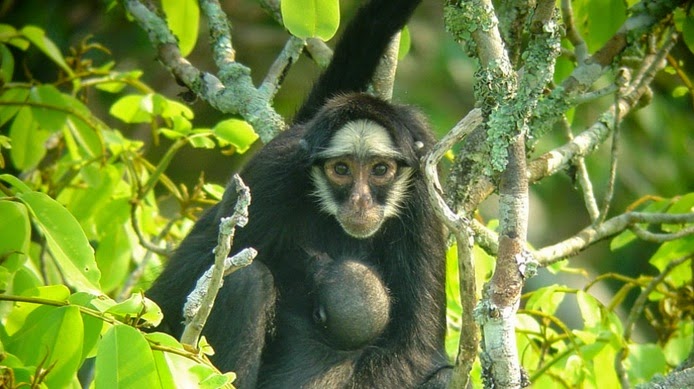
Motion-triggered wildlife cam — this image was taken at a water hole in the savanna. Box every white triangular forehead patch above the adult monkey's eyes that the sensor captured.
[318,120,402,159]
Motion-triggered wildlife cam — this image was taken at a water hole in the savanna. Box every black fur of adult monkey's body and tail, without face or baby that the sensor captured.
[147,0,450,388]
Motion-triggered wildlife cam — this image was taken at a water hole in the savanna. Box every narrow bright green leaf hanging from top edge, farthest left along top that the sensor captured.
[161,0,200,57]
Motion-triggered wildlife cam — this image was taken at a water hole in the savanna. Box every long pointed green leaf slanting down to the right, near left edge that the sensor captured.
[17,192,100,294]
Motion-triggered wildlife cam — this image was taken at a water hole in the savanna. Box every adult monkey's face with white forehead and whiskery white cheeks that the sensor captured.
[311,120,412,239]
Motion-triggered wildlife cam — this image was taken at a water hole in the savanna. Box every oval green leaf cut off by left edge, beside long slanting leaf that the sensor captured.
[0,200,31,272]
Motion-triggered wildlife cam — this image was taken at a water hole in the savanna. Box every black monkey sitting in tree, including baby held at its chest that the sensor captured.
[147,0,450,388]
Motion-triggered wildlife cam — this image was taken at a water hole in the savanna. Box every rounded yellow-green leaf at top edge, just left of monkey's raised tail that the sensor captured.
[280,0,340,41]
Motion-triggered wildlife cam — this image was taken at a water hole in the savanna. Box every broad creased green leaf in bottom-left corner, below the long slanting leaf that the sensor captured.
[5,306,84,388]
